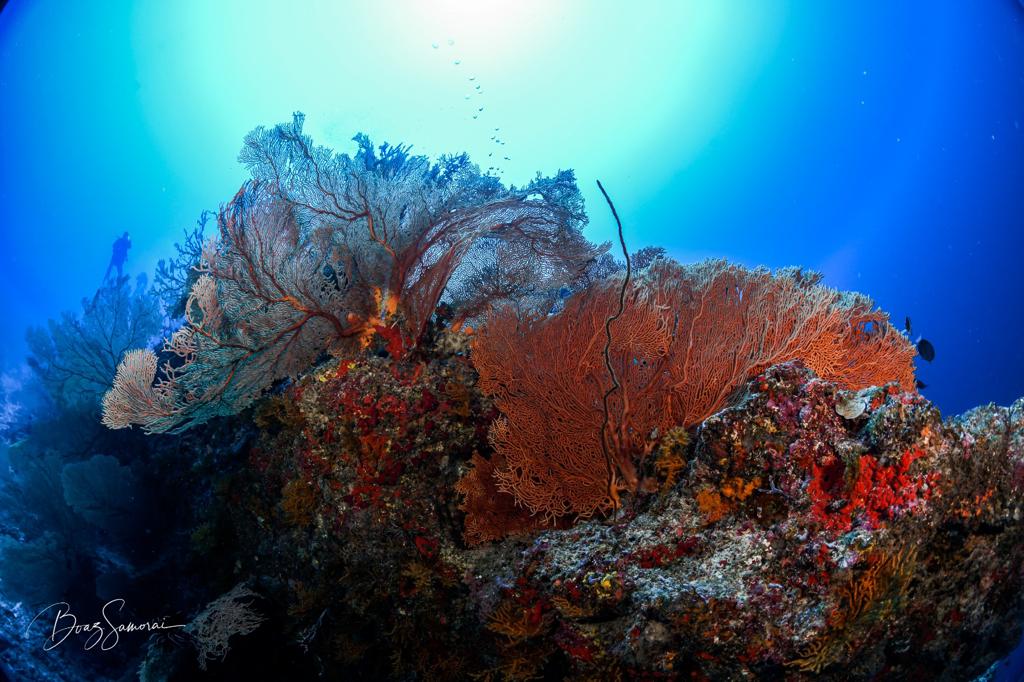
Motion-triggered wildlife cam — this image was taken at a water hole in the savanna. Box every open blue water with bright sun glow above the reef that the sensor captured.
[0,0,1024,679]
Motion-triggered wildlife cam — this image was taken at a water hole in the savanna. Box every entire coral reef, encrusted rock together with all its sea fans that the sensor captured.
[9,115,1024,680]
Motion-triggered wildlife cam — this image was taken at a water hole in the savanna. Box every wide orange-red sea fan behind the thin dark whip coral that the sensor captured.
[472,259,914,518]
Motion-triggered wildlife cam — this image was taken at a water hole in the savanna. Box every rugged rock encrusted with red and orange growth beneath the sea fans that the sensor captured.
[134,352,1024,680]
